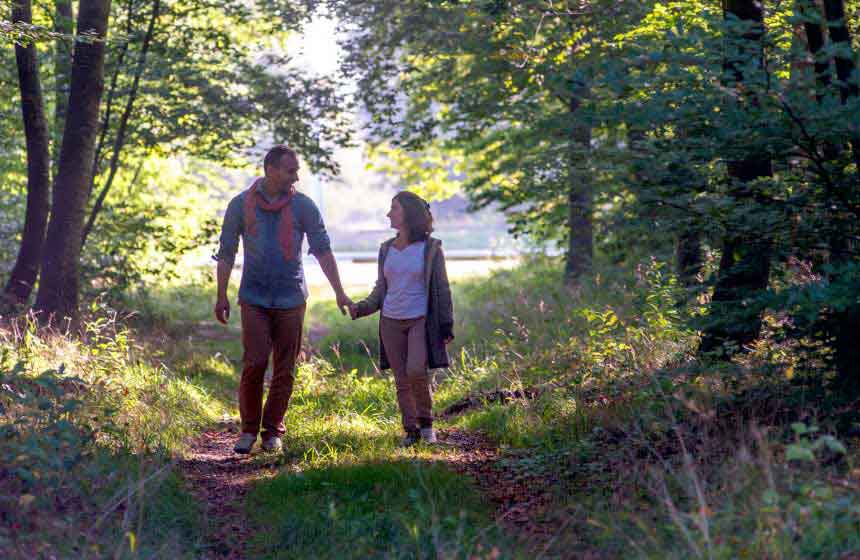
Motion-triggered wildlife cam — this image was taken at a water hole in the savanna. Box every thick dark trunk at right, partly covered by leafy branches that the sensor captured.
[699,0,773,355]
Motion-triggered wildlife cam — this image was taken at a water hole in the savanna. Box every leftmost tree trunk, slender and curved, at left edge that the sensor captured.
[3,0,51,304]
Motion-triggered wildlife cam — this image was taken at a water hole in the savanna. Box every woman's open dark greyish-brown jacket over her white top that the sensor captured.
[356,237,454,369]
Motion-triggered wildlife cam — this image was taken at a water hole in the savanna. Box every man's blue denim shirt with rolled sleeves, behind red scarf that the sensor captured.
[214,192,331,309]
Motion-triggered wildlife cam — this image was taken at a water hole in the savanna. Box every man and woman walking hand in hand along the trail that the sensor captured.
[214,145,454,454]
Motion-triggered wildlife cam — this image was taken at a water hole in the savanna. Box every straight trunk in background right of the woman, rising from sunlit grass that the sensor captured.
[564,82,594,284]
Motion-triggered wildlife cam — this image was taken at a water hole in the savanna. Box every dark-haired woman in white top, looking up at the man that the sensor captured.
[349,191,454,446]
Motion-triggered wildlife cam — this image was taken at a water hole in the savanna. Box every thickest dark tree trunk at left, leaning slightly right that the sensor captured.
[36,0,110,321]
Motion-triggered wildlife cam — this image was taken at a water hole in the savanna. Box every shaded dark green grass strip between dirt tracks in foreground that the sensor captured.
[249,460,507,558]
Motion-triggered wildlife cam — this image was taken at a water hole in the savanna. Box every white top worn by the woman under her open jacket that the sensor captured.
[382,241,427,319]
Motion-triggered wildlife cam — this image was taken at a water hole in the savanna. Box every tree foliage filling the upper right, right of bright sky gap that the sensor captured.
[332,0,860,375]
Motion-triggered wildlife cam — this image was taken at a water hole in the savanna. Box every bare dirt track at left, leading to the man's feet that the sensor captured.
[180,424,279,560]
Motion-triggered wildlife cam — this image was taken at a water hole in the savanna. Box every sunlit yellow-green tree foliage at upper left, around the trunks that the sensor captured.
[0,0,350,304]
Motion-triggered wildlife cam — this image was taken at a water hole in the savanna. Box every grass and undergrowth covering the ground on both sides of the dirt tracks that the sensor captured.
[0,260,860,559]
